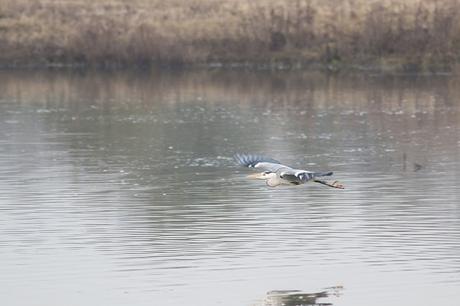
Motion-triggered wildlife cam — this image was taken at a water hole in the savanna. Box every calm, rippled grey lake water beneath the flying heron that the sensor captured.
[0,71,460,306]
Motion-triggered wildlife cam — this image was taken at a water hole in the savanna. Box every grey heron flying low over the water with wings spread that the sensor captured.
[234,154,344,189]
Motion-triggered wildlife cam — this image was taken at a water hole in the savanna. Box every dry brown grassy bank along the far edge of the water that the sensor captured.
[0,0,460,70]
